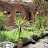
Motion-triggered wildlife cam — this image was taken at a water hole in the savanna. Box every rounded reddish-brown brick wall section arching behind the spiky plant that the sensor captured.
[10,5,28,25]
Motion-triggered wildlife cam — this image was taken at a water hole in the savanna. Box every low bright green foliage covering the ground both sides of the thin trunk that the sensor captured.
[0,29,42,43]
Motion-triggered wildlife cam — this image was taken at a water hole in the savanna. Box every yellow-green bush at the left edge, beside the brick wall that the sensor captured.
[0,12,7,30]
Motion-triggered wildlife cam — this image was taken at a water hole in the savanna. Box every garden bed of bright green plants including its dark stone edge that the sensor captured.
[0,30,48,47]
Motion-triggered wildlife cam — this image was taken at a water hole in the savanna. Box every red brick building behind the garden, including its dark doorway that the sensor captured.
[0,1,45,26]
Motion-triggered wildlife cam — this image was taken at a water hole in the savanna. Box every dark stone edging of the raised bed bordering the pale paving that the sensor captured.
[14,30,48,48]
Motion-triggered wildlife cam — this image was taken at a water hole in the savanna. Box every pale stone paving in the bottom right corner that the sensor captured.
[23,37,48,48]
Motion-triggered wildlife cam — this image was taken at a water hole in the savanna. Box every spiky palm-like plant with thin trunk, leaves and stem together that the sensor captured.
[15,14,27,39]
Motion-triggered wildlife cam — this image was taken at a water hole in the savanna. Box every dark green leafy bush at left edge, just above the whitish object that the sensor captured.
[0,31,14,42]
